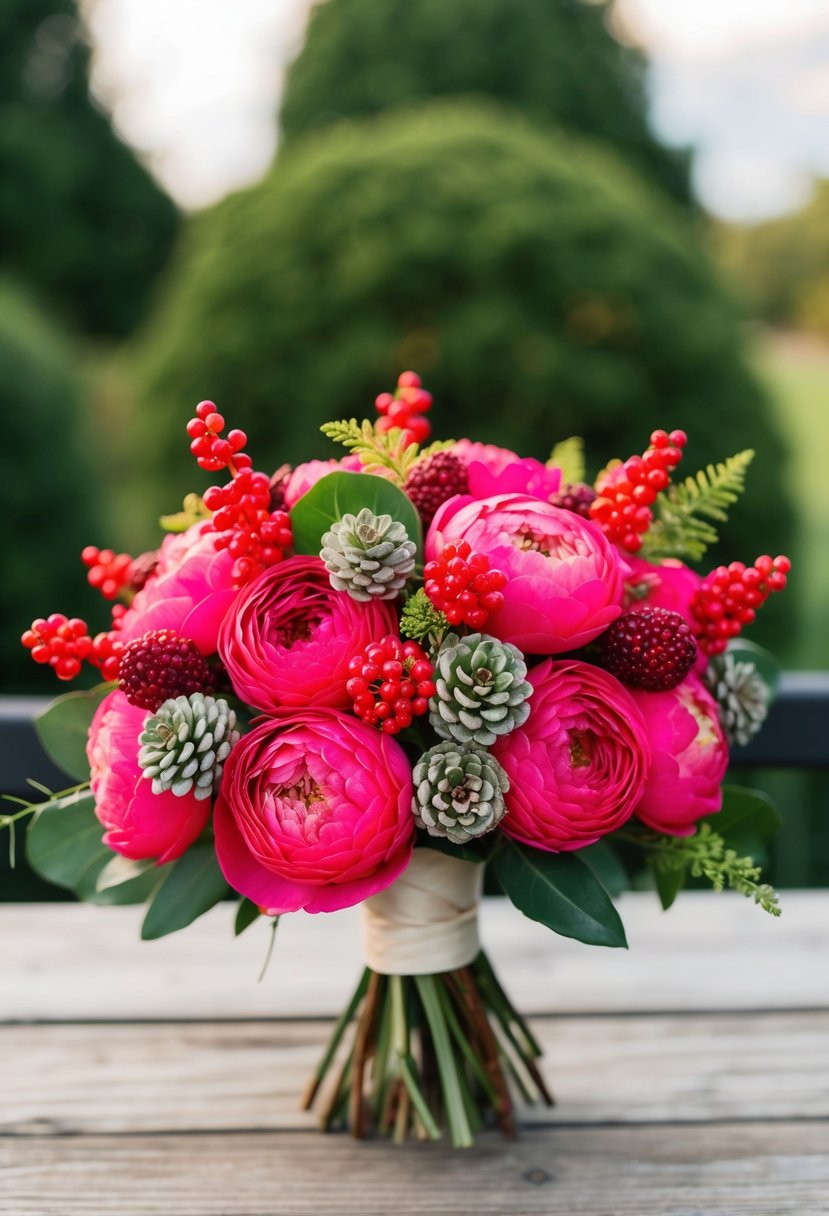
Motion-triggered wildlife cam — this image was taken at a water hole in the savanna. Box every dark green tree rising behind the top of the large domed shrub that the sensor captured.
[281,0,689,203]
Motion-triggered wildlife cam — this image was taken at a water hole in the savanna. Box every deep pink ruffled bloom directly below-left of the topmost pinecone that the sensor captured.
[219,557,397,714]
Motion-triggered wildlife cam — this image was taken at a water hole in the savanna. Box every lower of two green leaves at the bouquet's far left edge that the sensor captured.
[26,790,112,899]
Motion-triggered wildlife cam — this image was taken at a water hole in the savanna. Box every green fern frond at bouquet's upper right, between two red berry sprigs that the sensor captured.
[642,449,754,562]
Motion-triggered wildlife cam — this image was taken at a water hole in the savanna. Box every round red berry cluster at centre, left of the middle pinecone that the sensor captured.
[345,634,435,734]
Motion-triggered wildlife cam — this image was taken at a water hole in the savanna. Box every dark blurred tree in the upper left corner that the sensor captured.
[0,0,177,334]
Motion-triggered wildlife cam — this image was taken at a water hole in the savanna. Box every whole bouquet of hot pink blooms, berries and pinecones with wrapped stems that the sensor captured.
[9,372,789,1147]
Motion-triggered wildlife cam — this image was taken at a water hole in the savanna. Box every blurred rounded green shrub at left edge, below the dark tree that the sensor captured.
[0,283,99,696]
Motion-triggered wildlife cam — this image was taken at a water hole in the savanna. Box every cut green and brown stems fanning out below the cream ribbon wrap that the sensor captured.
[303,952,553,1148]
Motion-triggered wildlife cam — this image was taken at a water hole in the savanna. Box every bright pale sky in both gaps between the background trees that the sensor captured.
[84,0,829,223]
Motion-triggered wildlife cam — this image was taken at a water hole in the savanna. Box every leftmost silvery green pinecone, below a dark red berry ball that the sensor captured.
[139,692,239,799]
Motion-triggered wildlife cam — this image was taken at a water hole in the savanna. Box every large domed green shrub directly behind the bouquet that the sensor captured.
[133,103,785,569]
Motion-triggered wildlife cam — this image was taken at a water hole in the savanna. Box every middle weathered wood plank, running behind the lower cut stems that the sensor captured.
[0,1013,829,1144]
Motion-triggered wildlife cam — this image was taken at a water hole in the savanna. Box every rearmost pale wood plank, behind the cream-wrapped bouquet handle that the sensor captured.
[0,891,829,1021]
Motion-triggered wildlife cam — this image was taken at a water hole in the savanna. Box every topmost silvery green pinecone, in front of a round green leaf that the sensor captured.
[320,507,417,599]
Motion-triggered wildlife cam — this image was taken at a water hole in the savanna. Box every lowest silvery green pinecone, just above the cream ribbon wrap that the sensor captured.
[412,743,509,844]
